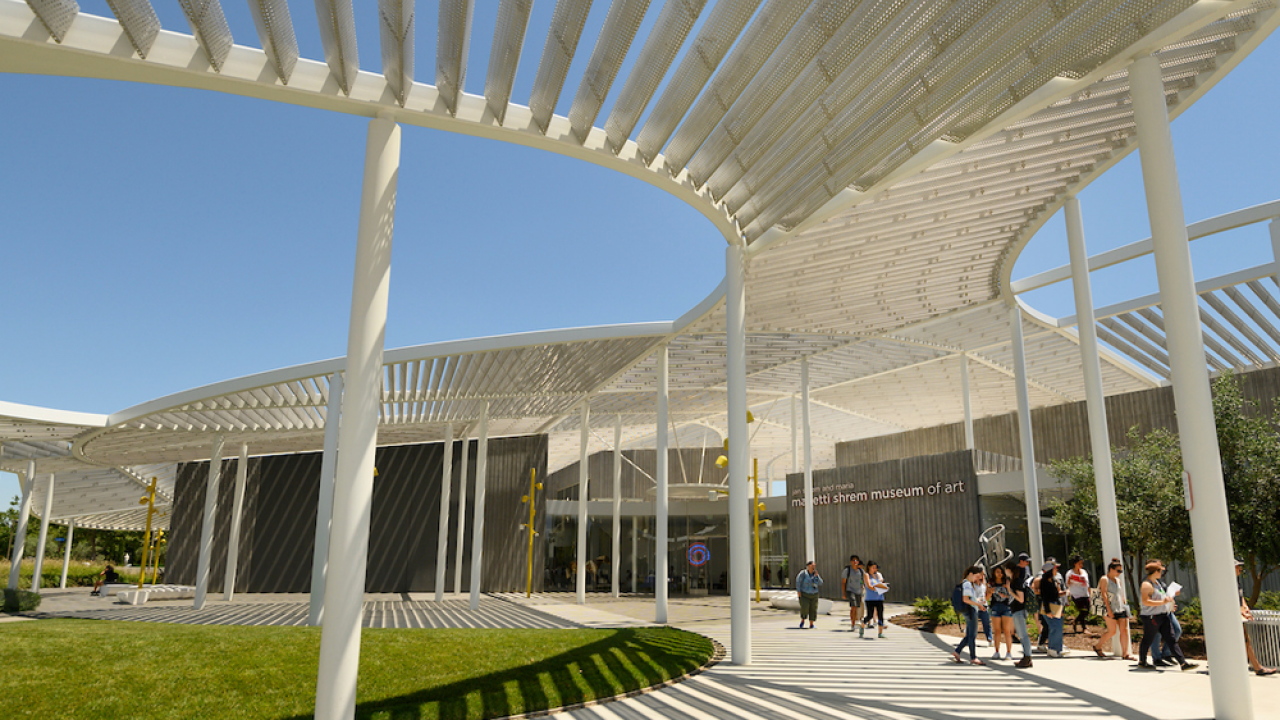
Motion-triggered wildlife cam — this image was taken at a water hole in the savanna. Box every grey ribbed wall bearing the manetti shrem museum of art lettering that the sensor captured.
[787,451,982,603]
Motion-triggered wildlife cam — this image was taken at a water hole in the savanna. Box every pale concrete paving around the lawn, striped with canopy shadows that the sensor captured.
[22,588,1280,720]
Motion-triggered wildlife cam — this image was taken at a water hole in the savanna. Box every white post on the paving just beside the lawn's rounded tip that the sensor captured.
[724,243,755,665]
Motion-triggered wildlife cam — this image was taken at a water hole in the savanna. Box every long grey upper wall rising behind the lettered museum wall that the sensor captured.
[836,368,1280,468]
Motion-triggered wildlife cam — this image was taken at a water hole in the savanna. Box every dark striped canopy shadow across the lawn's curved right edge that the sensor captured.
[277,628,712,720]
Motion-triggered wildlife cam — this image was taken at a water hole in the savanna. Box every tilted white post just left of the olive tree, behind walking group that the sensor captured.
[1064,196,1124,568]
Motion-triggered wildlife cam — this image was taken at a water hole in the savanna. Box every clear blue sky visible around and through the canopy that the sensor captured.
[0,0,1280,498]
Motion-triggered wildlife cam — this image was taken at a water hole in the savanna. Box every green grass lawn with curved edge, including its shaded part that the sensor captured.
[0,620,712,719]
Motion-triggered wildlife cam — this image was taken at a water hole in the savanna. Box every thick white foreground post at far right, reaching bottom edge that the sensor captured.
[1129,55,1253,720]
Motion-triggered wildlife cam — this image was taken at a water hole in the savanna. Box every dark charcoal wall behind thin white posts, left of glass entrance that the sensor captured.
[166,436,547,592]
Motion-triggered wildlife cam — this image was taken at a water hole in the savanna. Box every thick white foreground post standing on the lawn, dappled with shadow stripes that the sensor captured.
[316,115,401,720]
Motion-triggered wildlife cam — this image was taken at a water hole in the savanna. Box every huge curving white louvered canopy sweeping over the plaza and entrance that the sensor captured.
[0,0,1280,527]
